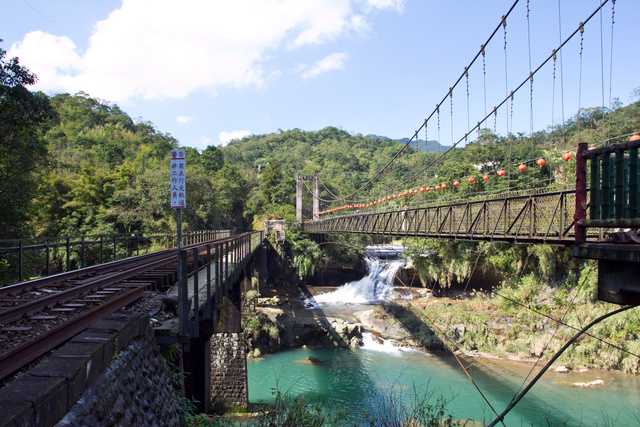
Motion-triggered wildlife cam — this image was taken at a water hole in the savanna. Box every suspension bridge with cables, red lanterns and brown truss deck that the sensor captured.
[296,1,640,304]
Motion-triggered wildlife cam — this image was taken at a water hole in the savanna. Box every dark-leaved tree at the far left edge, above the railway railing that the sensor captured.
[0,40,54,238]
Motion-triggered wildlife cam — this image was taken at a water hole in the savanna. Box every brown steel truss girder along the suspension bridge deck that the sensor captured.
[303,190,597,246]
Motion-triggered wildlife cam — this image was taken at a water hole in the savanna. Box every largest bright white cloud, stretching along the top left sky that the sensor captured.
[8,0,404,102]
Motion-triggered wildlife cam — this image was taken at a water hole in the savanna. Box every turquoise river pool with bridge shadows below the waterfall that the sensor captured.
[247,349,640,426]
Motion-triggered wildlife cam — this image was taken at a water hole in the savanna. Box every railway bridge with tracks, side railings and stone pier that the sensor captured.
[0,231,268,426]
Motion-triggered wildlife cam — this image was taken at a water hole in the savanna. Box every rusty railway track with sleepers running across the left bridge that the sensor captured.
[0,238,238,381]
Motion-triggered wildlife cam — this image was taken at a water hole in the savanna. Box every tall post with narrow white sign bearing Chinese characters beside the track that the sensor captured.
[169,150,189,337]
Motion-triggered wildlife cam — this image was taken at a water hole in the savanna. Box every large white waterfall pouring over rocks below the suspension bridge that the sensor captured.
[307,247,404,306]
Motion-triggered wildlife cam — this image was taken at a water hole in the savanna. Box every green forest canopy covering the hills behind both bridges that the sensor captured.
[0,49,640,239]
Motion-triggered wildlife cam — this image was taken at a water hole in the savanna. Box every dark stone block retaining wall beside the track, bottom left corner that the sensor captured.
[0,310,178,427]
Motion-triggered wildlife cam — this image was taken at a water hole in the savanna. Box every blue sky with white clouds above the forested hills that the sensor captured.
[0,0,640,149]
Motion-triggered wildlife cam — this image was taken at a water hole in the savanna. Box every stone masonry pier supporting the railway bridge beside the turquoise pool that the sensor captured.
[211,332,249,411]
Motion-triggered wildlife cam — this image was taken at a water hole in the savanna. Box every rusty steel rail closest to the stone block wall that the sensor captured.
[0,286,144,380]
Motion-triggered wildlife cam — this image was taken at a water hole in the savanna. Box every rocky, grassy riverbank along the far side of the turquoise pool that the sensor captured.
[242,285,637,373]
